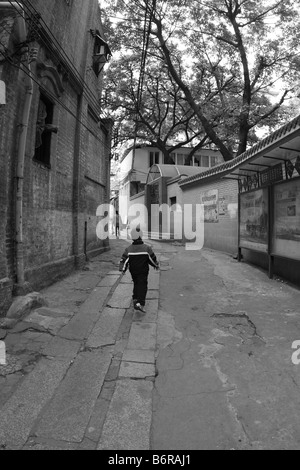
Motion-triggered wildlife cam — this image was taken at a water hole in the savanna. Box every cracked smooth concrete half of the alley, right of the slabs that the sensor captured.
[152,244,300,449]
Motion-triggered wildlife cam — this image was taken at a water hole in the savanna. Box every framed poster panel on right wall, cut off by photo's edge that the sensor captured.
[273,179,300,259]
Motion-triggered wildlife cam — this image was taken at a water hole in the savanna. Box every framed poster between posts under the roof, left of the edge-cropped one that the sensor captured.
[240,189,268,252]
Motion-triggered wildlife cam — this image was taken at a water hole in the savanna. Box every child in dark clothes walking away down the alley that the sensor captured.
[119,227,159,312]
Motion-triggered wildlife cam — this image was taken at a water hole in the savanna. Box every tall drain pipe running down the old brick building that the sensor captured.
[0,2,33,289]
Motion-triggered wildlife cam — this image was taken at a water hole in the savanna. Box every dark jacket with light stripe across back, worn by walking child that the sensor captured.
[119,239,158,274]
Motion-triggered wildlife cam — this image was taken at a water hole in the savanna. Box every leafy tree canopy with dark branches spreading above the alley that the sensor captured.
[104,0,300,160]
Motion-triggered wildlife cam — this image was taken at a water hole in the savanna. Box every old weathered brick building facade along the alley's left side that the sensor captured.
[0,0,111,316]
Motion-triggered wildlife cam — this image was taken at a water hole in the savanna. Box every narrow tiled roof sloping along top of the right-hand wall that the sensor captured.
[179,115,300,186]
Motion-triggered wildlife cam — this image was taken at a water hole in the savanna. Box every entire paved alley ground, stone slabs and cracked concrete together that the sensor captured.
[0,240,300,450]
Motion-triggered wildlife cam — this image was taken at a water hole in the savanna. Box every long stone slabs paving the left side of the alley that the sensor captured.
[0,240,164,450]
